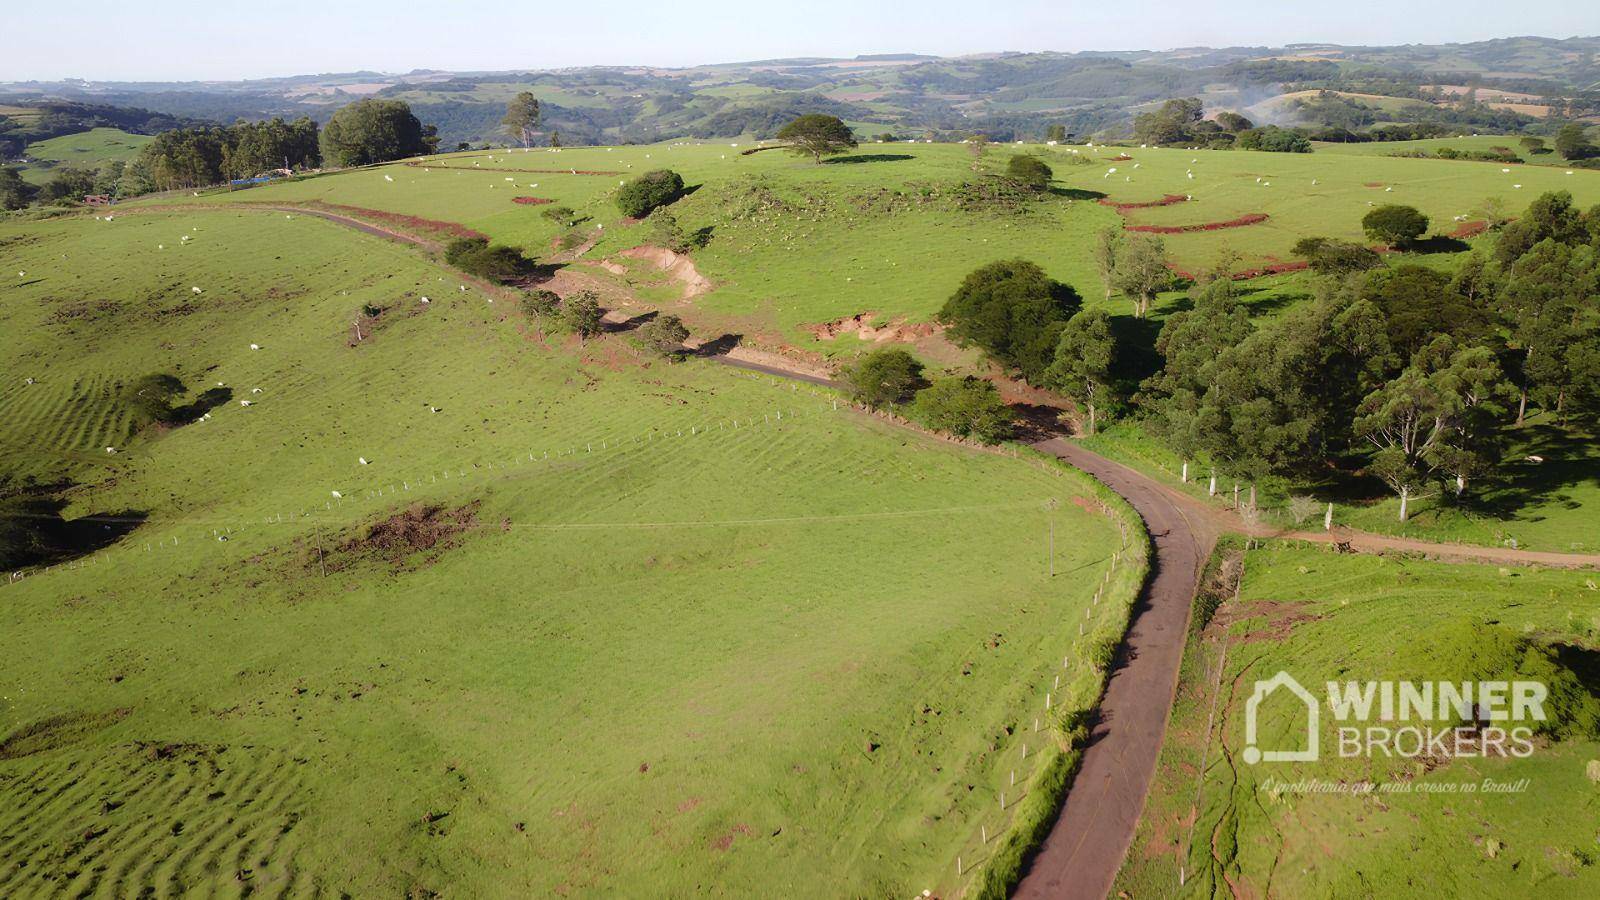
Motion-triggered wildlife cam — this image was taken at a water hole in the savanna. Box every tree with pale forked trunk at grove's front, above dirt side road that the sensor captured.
[1354,336,1501,522]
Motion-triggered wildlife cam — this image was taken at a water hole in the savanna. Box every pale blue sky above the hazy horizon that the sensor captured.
[0,0,1600,80]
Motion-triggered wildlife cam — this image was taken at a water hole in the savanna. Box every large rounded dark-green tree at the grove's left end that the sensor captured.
[939,259,1082,383]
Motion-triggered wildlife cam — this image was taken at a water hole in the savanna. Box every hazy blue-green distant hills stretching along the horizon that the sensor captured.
[0,37,1600,147]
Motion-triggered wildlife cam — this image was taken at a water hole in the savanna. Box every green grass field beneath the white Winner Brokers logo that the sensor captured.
[1114,544,1600,897]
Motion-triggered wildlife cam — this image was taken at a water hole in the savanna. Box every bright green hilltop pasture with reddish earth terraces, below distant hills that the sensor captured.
[178,141,1600,354]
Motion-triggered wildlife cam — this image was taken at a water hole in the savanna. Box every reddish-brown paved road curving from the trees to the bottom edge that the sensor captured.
[1016,437,1218,900]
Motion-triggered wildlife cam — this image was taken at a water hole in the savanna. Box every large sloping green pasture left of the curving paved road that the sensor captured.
[0,208,1131,897]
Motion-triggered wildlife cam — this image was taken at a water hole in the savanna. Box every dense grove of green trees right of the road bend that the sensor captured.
[846,192,1600,520]
